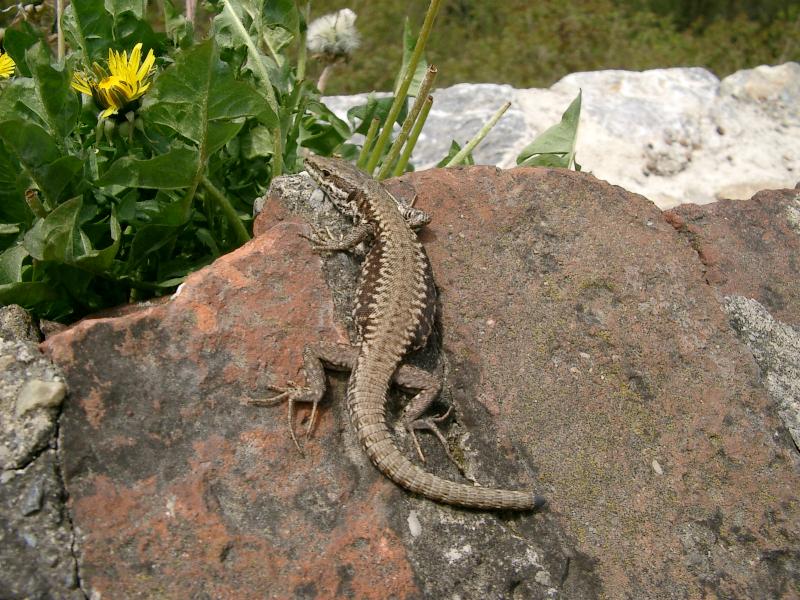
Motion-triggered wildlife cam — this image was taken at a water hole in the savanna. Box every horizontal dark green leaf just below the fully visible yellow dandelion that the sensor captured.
[97,147,199,189]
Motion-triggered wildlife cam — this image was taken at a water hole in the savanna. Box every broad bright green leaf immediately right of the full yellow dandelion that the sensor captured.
[142,39,277,154]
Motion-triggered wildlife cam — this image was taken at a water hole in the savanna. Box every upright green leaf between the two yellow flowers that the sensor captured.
[25,43,80,139]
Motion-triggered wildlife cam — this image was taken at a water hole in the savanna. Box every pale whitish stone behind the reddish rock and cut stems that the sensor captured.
[326,62,800,208]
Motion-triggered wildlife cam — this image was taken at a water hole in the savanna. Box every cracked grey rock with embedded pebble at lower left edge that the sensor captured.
[0,306,80,600]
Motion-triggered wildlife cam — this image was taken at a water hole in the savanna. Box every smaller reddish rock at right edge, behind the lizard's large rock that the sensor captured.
[665,190,800,325]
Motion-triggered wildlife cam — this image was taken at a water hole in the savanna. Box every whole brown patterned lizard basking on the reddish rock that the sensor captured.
[258,155,545,510]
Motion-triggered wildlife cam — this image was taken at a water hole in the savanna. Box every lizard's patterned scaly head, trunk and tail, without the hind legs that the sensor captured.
[305,156,544,510]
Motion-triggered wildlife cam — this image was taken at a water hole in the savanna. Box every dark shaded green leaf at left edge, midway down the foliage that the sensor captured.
[0,121,83,206]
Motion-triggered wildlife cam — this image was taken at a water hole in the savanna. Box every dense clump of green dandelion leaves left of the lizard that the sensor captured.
[0,0,358,320]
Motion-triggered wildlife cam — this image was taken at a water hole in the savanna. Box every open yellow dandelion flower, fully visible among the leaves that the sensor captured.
[72,44,156,119]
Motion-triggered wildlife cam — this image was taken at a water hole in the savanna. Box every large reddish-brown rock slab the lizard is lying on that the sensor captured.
[39,168,800,599]
